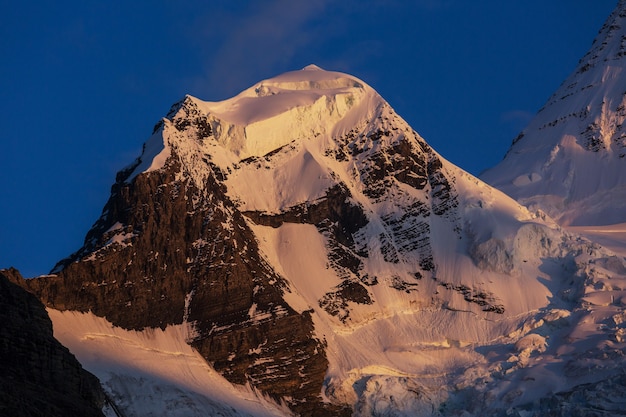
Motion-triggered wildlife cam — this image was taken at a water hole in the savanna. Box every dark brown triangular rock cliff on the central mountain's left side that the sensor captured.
[19,136,336,415]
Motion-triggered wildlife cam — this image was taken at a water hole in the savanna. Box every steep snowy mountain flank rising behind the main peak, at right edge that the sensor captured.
[481,0,626,225]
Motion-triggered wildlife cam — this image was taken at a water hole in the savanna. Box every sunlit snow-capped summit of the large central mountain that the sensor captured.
[123,65,384,184]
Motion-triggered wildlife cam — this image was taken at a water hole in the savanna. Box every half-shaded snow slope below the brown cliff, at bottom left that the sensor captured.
[48,309,286,417]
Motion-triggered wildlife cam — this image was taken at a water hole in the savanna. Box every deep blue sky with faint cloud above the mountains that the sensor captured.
[0,0,617,277]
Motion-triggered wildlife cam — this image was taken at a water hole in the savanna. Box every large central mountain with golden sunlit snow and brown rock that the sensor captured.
[15,66,626,416]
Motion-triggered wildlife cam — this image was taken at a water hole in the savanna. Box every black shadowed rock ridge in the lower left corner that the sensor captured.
[0,269,104,417]
